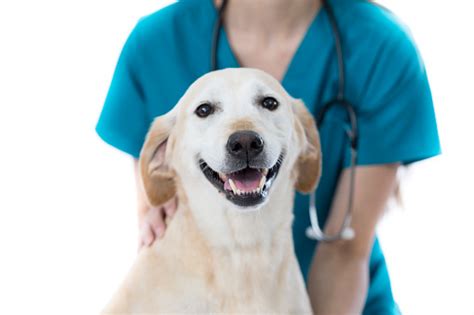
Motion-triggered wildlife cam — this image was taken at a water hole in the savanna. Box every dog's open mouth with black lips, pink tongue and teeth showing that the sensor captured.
[199,156,283,207]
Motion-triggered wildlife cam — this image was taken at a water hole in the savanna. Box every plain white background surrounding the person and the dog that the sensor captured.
[0,0,474,314]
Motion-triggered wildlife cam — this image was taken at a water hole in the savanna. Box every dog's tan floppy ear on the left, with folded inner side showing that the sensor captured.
[139,110,176,207]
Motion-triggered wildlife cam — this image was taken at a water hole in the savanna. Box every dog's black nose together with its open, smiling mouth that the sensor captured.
[199,130,283,207]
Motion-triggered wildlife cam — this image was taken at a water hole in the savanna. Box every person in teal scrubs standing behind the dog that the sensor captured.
[96,0,440,314]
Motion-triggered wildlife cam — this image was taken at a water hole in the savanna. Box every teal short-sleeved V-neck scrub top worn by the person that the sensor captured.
[96,0,440,314]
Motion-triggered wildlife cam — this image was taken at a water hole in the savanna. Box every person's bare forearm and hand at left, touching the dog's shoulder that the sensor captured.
[133,160,176,248]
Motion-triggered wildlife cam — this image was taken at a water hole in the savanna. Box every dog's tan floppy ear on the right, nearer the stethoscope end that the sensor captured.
[293,100,322,193]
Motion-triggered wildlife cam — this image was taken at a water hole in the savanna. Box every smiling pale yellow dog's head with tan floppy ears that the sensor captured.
[140,68,321,210]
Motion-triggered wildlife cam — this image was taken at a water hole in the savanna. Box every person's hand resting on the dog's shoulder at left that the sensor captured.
[139,197,177,249]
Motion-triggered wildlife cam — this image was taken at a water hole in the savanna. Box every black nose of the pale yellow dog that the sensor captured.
[227,130,264,160]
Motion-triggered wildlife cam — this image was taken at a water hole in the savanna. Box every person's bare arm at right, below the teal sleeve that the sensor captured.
[308,164,399,315]
